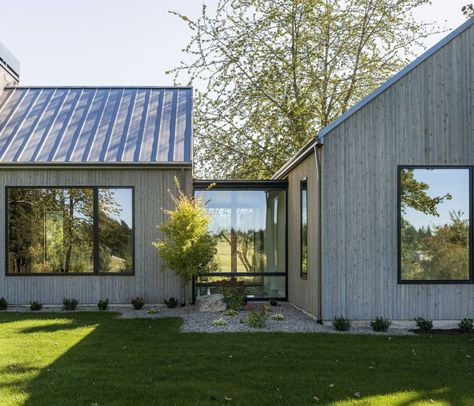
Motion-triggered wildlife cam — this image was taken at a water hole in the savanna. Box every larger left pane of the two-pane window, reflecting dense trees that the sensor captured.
[8,188,94,273]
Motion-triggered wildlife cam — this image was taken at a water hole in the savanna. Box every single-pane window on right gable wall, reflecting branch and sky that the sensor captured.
[400,168,470,281]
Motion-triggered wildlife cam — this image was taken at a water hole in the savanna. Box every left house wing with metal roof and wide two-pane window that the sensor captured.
[0,42,192,304]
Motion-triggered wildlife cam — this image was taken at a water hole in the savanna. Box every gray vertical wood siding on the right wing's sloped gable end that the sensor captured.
[322,26,474,320]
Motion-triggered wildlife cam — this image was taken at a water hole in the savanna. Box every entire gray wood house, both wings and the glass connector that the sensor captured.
[0,18,474,321]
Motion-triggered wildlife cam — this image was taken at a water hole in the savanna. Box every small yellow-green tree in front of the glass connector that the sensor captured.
[153,179,217,304]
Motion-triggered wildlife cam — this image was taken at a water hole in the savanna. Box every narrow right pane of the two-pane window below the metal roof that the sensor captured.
[99,188,133,272]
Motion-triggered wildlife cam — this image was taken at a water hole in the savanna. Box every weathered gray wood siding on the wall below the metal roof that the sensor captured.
[0,168,192,304]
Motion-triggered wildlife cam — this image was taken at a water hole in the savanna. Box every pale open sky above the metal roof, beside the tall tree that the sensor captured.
[0,0,468,86]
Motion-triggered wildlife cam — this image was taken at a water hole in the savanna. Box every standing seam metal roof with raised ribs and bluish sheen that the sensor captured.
[0,87,192,164]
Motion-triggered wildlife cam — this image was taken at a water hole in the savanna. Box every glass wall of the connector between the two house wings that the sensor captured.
[195,187,286,298]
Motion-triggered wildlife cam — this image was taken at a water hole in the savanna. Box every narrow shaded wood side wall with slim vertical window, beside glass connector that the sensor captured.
[288,154,319,316]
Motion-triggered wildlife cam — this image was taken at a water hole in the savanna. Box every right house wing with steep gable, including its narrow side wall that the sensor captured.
[274,18,474,320]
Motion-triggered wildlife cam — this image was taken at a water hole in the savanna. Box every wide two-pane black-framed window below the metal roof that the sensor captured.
[6,187,133,275]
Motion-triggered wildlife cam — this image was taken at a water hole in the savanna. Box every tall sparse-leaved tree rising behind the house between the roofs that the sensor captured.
[170,0,437,178]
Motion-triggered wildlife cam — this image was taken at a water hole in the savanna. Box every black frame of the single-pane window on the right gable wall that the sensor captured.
[397,165,474,285]
